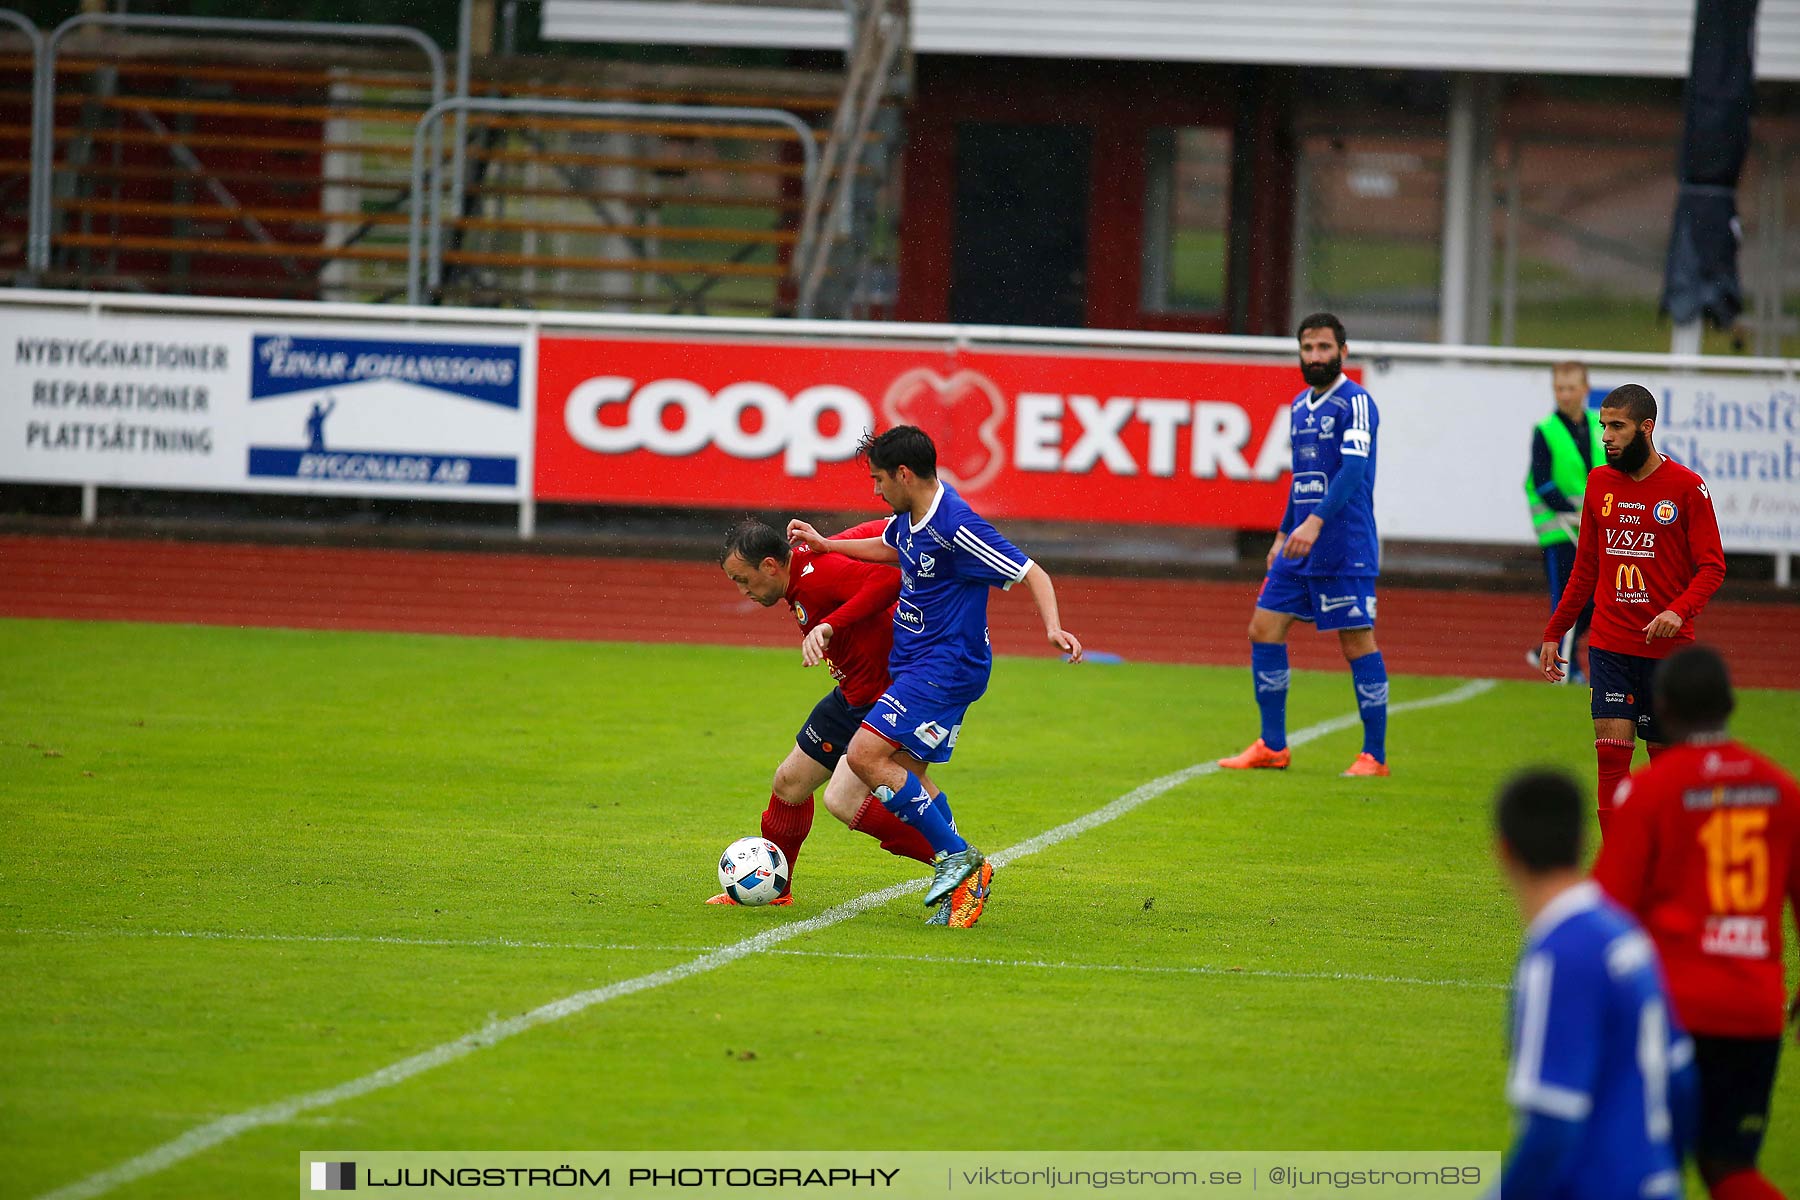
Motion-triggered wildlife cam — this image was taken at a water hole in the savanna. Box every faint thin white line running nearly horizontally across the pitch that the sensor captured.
[13,928,1512,988]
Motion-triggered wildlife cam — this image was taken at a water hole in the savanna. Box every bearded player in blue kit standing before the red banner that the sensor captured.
[1219,313,1388,775]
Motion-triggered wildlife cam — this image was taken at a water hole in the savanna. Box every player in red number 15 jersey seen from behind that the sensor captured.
[1593,646,1800,1200]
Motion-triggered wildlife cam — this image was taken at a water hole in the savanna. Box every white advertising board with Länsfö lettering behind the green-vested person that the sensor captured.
[1364,362,1800,554]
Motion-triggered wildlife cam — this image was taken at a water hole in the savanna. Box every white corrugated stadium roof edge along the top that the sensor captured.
[544,0,1800,79]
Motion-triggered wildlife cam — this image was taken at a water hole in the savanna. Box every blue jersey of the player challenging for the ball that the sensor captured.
[882,482,1031,700]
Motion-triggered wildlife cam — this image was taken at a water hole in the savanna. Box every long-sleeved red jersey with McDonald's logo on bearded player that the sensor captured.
[1544,459,1724,658]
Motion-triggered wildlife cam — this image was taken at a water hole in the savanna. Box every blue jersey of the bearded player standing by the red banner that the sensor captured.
[1282,376,1381,576]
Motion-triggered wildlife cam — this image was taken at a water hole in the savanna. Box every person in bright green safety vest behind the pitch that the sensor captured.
[1525,362,1606,684]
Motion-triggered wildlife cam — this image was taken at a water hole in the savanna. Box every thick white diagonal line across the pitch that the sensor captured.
[38,680,1494,1200]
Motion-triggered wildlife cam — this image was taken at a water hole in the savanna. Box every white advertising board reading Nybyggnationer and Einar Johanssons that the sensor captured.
[0,309,535,500]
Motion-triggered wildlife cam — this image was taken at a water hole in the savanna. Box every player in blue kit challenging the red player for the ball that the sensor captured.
[788,425,1082,925]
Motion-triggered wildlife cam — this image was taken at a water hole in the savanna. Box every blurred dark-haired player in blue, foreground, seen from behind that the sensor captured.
[1494,770,1697,1200]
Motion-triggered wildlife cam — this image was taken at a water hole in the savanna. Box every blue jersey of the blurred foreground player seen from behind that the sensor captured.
[1507,880,1694,1200]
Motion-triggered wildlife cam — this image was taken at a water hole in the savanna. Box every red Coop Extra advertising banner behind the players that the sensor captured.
[536,336,1324,529]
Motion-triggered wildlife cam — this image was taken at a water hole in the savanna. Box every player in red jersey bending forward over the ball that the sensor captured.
[707,520,932,905]
